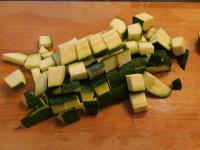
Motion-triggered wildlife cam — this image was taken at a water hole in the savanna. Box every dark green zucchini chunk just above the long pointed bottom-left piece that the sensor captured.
[22,91,45,109]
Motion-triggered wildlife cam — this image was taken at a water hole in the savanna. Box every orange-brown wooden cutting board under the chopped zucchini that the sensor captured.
[0,2,200,150]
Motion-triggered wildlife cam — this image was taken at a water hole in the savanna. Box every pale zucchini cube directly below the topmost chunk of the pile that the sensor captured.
[128,23,142,41]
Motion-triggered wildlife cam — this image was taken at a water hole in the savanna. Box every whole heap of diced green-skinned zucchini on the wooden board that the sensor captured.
[3,13,189,127]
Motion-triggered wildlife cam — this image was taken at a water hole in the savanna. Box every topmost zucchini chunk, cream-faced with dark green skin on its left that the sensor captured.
[132,13,154,31]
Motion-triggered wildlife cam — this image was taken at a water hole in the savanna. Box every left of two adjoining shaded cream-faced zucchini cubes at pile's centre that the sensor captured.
[103,55,119,73]
